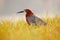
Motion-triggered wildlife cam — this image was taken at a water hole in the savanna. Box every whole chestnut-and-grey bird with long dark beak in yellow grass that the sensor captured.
[18,9,46,25]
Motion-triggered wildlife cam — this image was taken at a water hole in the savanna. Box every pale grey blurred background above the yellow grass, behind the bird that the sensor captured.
[0,0,60,19]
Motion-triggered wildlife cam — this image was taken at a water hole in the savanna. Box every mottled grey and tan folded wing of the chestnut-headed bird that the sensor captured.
[27,15,46,25]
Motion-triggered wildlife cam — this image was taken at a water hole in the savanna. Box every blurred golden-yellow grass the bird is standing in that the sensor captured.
[0,17,60,40]
